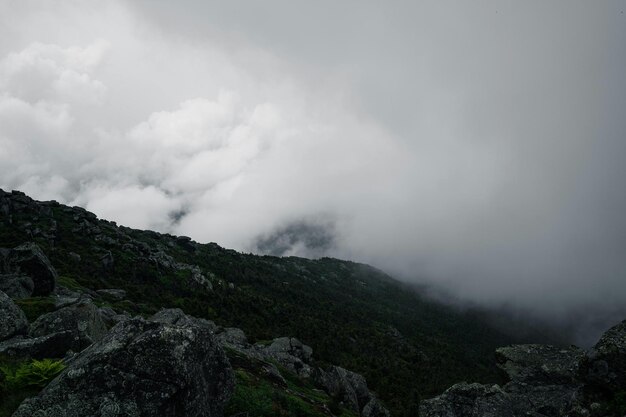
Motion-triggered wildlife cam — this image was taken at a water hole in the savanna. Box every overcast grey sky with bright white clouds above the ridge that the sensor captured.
[0,0,626,342]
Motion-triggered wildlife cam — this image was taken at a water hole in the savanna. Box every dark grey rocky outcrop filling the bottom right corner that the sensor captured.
[420,321,626,417]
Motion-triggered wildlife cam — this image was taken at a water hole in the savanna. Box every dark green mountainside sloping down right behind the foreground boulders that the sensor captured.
[0,190,528,415]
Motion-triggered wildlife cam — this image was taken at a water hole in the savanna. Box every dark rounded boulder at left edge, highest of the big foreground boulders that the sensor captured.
[0,243,57,297]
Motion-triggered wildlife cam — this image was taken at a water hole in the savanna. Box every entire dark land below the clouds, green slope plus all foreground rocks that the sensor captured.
[0,190,626,417]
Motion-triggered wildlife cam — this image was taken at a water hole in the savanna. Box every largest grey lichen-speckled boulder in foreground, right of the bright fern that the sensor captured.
[13,318,234,417]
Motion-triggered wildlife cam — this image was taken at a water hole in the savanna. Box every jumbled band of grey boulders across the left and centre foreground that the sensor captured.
[0,244,389,417]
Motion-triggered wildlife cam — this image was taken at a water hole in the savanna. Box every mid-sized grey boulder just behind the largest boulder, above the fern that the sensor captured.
[29,299,107,351]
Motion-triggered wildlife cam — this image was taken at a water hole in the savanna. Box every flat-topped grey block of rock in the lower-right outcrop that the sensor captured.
[496,345,585,384]
